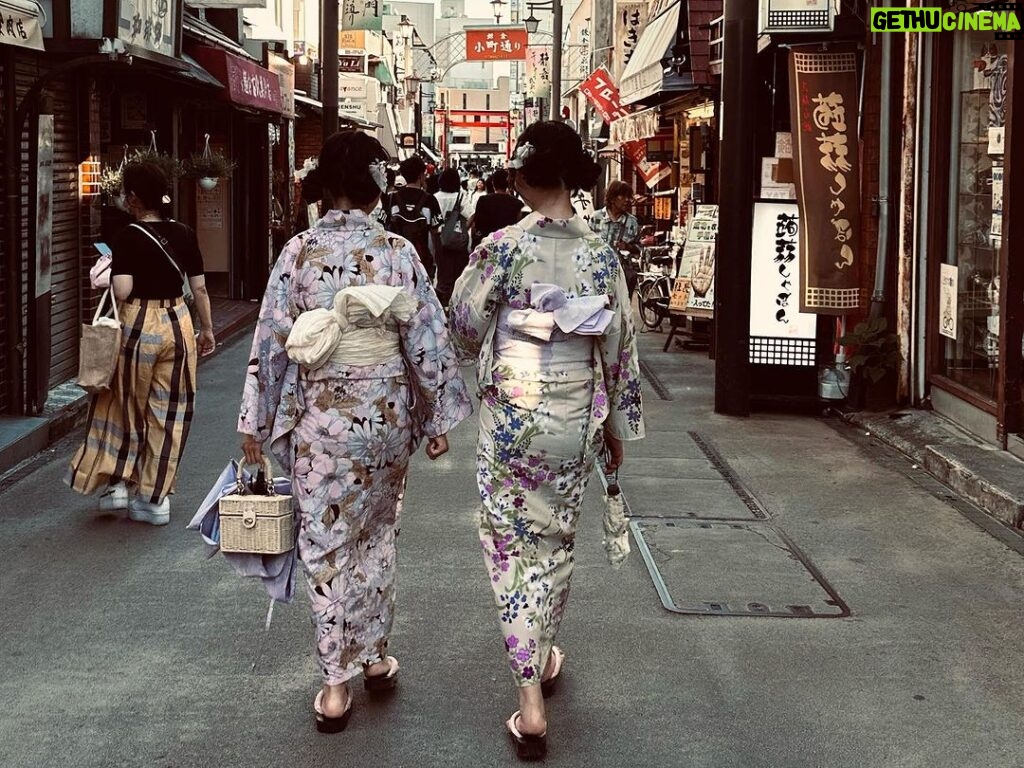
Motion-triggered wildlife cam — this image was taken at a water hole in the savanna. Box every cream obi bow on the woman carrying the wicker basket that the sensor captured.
[285,285,418,369]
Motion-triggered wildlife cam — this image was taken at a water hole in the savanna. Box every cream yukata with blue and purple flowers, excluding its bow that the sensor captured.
[450,214,644,685]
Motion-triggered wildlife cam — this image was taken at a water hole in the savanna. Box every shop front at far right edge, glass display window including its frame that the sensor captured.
[919,31,1024,453]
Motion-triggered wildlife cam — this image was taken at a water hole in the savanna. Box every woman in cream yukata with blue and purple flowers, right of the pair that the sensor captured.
[450,122,644,759]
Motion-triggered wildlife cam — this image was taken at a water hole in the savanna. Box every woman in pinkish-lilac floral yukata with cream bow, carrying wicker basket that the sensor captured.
[239,132,472,733]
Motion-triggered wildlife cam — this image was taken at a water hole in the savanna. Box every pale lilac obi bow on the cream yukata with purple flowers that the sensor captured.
[508,283,614,341]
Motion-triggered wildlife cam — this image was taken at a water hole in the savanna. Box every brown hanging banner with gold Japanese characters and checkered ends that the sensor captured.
[790,50,861,314]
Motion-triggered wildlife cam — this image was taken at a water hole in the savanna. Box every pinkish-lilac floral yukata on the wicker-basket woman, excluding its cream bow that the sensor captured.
[239,211,471,684]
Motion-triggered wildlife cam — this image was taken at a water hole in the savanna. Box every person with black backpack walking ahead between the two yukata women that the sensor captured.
[385,155,441,282]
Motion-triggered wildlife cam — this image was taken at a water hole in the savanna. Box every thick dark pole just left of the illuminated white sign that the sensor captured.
[715,0,758,416]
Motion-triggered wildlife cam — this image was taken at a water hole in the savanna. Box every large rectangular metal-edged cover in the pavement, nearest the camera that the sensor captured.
[630,517,850,618]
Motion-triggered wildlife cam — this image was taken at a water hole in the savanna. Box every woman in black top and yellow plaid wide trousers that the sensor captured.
[65,163,216,525]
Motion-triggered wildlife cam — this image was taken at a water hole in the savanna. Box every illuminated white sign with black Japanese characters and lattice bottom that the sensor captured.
[750,203,817,366]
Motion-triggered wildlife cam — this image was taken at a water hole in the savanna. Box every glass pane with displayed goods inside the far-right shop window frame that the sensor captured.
[942,33,1007,400]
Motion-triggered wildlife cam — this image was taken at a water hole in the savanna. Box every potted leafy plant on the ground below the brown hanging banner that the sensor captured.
[839,317,903,411]
